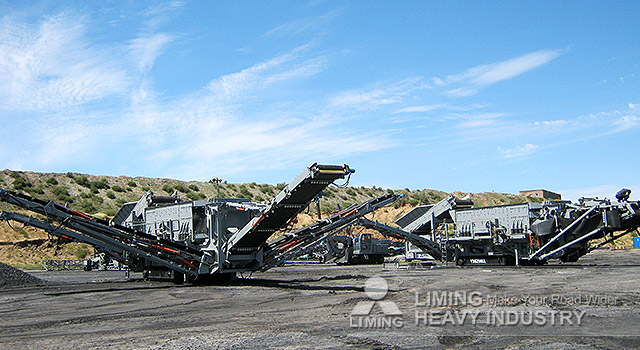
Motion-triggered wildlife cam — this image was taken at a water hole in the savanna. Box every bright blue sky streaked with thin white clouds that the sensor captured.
[0,1,640,199]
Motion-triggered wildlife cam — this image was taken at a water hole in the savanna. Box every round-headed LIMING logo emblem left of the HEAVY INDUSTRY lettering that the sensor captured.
[349,276,404,328]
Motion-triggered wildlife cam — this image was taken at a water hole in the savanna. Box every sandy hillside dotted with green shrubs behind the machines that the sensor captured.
[5,170,628,265]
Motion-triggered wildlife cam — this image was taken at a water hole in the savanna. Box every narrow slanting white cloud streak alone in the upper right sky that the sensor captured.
[432,50,562,97]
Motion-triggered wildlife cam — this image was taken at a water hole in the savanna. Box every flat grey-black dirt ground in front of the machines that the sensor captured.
[0,250,640,349]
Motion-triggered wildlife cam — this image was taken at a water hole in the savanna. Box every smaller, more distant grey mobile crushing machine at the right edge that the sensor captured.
[360,194,640,265]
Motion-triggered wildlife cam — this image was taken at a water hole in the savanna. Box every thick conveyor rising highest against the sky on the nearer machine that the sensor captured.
[227,164,354,254]
